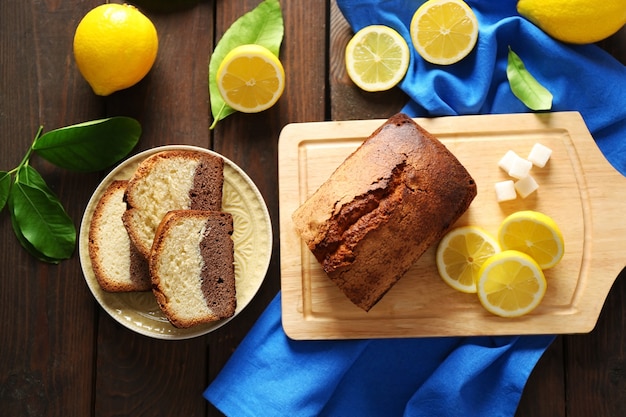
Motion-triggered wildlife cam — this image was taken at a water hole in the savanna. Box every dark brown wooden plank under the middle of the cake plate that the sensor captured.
[89,2,213,416]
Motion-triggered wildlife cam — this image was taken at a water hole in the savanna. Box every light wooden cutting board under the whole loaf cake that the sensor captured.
[279,112,626,339]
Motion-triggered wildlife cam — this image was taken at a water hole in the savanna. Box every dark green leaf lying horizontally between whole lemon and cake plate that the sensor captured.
[33,117,141,172]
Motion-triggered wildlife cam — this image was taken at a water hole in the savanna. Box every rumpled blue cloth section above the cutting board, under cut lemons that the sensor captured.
[337,0,626,175]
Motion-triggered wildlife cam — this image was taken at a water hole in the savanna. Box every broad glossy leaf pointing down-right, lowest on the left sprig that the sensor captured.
[9,181,76,262]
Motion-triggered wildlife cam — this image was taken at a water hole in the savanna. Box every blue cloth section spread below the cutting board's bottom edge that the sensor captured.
[204,294,553,417]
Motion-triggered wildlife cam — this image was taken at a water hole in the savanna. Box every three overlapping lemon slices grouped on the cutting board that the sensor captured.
[436,210,564,317]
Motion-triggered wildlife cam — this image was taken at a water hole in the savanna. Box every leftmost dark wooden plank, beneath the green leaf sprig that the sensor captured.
[0,1,100,416]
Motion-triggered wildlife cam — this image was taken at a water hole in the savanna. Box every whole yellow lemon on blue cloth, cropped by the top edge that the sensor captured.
[517,0,626,44]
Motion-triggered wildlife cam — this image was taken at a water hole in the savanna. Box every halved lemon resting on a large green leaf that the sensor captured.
[216,44,285,113]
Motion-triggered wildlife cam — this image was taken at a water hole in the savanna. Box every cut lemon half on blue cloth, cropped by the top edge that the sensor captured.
[410,0,478,65]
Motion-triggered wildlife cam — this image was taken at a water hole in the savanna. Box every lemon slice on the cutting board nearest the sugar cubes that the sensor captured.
[498,210,565,269]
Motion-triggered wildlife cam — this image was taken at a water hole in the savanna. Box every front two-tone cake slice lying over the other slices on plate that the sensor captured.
[149,210,237,328]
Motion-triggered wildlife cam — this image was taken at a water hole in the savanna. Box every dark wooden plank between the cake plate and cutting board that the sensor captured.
[208,0,327,416]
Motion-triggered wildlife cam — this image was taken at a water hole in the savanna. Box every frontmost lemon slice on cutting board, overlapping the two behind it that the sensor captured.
[476,250,547,317]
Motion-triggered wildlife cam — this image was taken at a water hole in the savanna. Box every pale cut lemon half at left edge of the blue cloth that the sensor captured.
[345,25,410,91]
